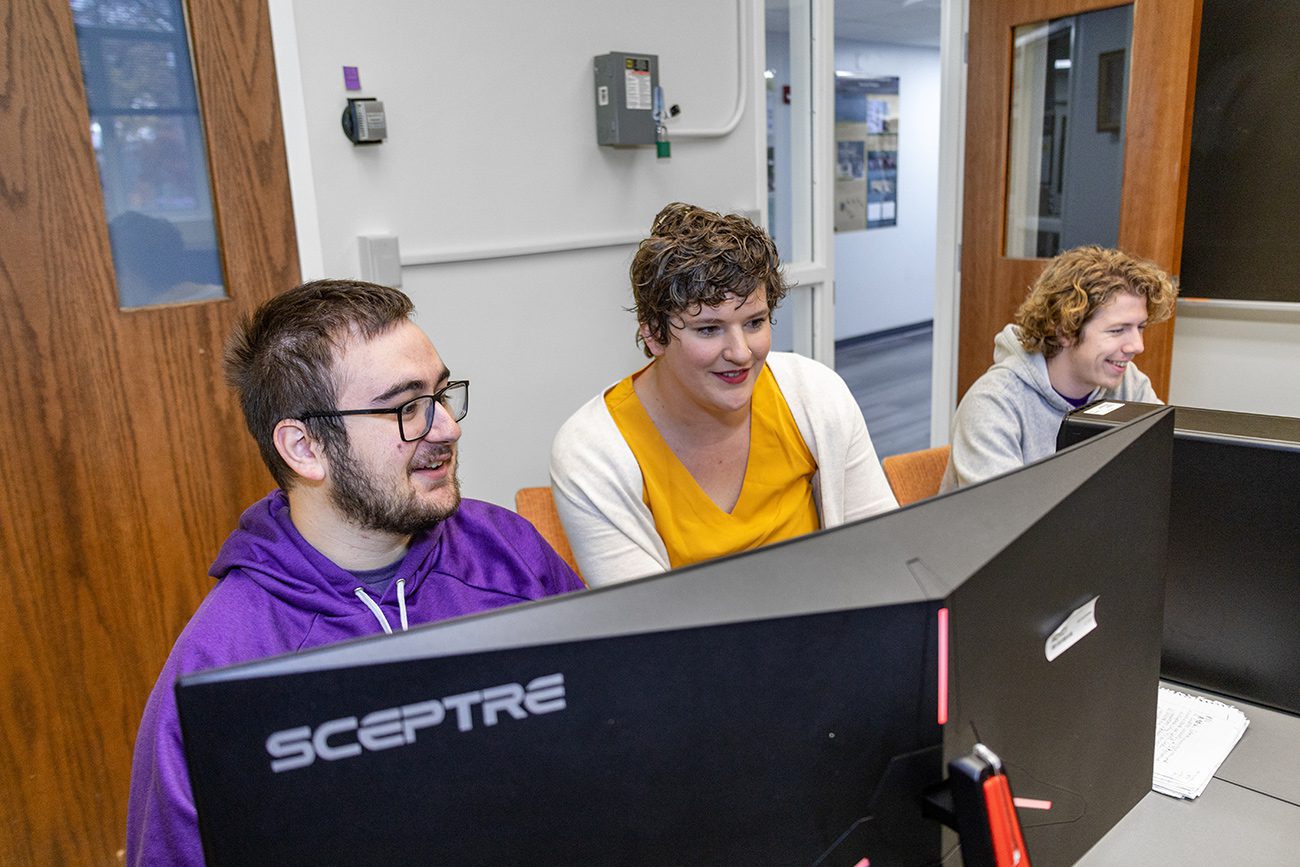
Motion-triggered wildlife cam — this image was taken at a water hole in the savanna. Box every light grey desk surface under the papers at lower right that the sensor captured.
[1076,684,1300,867]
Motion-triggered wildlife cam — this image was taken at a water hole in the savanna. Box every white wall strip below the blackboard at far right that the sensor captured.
[1170,303,1300,417]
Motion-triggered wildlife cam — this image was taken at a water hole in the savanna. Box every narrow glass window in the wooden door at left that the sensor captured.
[72,0,226,308]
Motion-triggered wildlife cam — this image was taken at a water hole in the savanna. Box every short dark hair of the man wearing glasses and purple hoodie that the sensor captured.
[225,279,415,490]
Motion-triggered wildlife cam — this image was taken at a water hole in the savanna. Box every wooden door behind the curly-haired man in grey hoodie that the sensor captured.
[957,0,1201,398]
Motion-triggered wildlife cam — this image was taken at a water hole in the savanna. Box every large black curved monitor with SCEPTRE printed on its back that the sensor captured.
[177,411,1171,867]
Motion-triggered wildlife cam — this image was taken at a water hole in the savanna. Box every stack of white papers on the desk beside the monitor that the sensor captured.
[1152,686,1251,798]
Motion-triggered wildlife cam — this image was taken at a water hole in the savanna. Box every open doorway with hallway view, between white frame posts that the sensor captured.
[833,0,941,456]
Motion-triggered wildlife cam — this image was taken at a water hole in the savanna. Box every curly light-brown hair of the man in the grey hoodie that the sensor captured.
[1015,244,1178,359]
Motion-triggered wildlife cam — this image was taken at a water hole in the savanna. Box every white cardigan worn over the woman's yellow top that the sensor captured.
[551,352,898,586]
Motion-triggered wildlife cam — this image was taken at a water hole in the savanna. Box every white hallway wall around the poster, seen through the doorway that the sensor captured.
[835,39,940,341]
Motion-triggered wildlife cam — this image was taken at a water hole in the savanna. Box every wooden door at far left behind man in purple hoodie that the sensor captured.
[0,0,298,864]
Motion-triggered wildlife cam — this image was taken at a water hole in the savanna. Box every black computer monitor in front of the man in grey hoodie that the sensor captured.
[1058,402,1300,714]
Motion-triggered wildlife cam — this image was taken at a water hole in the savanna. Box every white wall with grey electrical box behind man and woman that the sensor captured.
[272,0,766,506]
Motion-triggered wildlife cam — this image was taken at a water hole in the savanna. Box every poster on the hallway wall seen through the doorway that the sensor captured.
[835,74,898,231]
